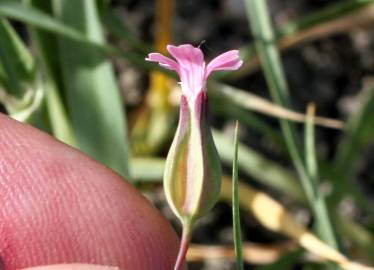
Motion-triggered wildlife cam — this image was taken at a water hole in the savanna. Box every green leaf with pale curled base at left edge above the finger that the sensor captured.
[0,18,50,132]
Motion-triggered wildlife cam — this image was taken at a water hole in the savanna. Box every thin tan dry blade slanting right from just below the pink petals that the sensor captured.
[211,83,344,129]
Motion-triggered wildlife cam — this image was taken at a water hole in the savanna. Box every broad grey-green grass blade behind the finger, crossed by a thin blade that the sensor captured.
[55,0,129,176]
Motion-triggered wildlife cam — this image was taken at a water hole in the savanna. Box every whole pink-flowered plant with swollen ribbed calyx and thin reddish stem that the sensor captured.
[146,44,242,270]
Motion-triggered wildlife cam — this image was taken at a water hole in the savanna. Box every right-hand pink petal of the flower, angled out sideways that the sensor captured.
[205,50,243,77]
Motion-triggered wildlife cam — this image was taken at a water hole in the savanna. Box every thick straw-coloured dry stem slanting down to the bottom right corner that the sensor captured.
[221,177,374,270]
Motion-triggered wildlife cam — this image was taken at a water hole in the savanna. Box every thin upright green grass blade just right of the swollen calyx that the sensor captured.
[232,122,244,270]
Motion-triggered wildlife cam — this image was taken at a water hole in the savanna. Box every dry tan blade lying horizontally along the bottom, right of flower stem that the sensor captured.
[187,242,296,265]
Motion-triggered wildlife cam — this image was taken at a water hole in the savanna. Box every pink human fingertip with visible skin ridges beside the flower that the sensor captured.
[0,114,179,270]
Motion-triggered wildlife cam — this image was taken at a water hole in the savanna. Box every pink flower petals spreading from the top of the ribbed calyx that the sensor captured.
[146,44,243,99]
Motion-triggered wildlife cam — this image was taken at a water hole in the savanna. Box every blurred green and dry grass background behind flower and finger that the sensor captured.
[0,0,374,269]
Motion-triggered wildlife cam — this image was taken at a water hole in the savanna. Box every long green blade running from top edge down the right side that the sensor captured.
[245,0,336,255]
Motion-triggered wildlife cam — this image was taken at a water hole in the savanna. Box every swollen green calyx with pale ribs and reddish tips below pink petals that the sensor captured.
[164,91,221,224]
